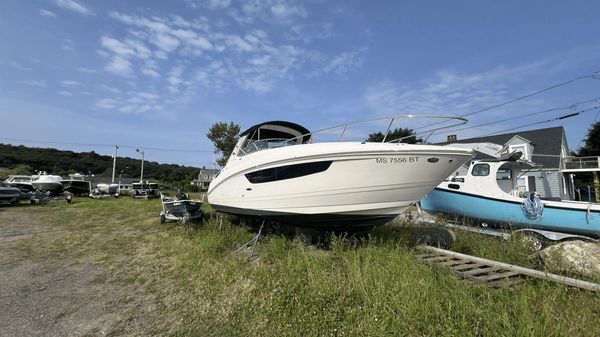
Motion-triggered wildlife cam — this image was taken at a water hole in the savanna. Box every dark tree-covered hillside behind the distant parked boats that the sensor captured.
[0,144,200,182]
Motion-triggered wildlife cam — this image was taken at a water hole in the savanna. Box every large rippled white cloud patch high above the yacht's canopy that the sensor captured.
[99,7,364,96]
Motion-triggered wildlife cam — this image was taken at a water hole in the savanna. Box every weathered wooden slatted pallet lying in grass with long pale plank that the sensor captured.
[417,246,600,291]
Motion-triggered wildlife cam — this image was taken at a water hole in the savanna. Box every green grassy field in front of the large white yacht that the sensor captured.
[4,198,600,336]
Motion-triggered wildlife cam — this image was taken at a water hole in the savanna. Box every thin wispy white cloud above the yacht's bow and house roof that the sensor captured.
[365,61,550,129]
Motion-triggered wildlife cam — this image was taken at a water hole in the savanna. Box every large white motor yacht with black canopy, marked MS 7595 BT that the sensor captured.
[207,116,473,230]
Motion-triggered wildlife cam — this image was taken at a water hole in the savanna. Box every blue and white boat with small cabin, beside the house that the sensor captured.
[421,155,600,237]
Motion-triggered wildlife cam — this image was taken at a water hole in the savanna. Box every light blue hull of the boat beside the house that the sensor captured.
[421,188,600,237]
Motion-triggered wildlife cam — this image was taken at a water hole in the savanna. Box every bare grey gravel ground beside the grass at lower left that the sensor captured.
[0,205,153,337]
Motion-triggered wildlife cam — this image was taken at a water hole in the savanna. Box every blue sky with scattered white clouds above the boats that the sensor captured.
[0,0,600,167]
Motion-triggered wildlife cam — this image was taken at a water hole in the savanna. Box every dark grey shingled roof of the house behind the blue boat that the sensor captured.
[444,126,569,168]
